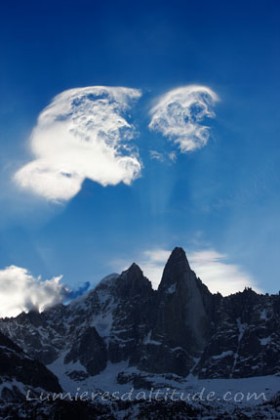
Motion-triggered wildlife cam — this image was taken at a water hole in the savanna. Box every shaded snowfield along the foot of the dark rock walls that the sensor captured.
[48,346,280,407]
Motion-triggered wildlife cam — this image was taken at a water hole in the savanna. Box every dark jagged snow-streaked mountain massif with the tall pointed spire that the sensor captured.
[0,248,280,416]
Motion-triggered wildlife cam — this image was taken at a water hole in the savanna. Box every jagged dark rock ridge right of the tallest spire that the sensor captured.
[196,289,280,378]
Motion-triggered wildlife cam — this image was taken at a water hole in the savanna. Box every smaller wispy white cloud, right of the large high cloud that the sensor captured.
[149,85,218,153]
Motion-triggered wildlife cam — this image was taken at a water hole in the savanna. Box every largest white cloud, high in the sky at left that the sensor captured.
[14,86,142,202]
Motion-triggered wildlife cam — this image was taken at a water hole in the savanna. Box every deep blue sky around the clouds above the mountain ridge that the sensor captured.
[0,0,280,312]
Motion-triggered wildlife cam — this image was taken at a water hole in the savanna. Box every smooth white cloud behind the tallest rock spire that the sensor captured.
[117,249,260,296]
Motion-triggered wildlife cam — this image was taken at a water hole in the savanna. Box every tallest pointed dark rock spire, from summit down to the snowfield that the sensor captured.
[136,248,211,376]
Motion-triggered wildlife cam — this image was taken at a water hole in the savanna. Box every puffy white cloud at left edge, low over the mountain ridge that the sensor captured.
[0,265,64,317]
